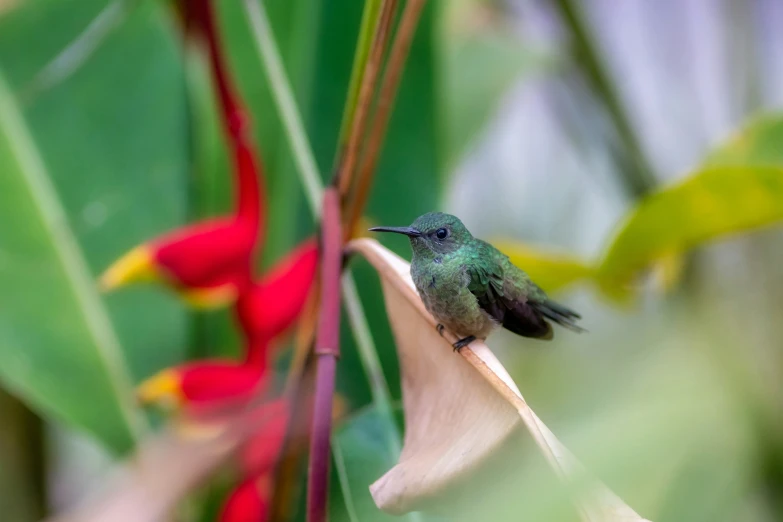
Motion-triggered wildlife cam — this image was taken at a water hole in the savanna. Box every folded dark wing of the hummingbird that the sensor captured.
[465,243,552,339]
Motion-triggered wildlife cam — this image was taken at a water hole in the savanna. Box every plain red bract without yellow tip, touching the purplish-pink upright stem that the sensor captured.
[236,239,318,363]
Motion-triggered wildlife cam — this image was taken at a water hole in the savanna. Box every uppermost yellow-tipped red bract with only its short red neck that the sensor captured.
[100,140,263,308]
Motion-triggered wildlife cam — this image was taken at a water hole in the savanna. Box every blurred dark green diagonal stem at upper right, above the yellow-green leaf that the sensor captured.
[554,0,656,198]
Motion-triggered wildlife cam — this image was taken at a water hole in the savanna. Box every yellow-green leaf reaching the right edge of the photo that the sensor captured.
[597,118,783,297]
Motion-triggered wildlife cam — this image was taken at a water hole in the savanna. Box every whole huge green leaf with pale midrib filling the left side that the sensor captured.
[0,0,188,451]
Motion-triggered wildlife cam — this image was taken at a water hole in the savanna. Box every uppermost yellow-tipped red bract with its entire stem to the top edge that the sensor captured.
[101,0,264,308]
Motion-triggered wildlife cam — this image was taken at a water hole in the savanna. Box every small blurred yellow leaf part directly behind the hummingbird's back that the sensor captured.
[493,240,593,292]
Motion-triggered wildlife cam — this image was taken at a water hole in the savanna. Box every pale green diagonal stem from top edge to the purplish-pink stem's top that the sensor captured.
[245,0,323,216]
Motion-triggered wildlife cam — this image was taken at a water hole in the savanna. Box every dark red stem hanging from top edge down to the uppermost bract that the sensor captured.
[181,0,265,234]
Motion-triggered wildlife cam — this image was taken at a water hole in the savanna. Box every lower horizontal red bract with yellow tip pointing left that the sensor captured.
[136,360,267,415]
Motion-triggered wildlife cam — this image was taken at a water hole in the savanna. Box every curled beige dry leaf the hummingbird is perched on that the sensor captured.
[348,239,656,522]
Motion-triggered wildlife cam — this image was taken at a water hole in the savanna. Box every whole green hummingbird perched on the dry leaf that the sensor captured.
[370,212,584,351]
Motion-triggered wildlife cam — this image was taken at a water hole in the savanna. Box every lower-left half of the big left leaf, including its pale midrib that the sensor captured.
[0,69,140,451]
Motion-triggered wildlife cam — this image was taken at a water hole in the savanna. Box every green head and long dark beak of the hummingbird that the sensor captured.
[370,212,473,258]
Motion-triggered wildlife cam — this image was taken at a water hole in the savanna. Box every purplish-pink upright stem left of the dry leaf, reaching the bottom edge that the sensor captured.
[307,187,342,522]
